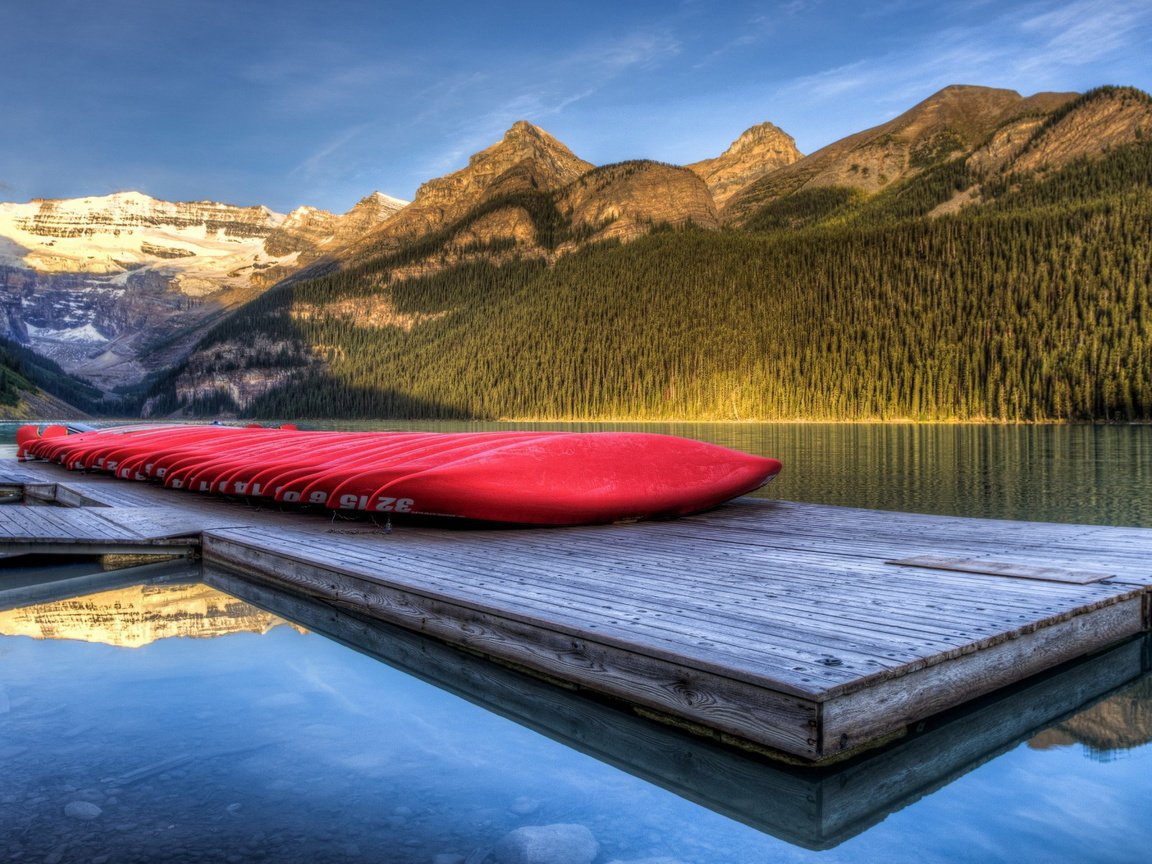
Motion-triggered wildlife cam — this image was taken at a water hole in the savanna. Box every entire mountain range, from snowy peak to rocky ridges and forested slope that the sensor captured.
[0,86,1152,419]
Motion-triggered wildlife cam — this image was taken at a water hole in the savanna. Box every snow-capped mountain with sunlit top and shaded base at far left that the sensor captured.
[0,192,404,387]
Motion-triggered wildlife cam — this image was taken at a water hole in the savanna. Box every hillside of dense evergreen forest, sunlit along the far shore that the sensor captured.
[150,129,1152,420]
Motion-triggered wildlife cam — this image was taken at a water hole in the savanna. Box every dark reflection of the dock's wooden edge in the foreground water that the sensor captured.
[204,566,1149,849]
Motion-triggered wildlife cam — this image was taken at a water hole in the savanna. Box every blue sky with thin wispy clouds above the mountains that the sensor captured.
[0,0,1152,212]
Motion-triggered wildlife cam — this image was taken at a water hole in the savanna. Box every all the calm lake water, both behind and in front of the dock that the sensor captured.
[0,425,1152,864]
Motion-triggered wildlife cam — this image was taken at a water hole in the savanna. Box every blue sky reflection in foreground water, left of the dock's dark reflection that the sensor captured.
[0,576,755,862]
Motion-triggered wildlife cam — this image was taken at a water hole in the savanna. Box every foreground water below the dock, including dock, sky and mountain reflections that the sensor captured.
[0,567,1152,864]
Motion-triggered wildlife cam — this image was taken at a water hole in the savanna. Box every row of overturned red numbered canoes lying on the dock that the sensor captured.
[17,426,780,525]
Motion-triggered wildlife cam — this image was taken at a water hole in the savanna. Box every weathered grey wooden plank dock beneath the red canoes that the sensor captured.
[0,462,1152,764]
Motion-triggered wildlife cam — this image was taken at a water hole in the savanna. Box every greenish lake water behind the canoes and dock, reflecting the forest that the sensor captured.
[0,420,1152,526]
